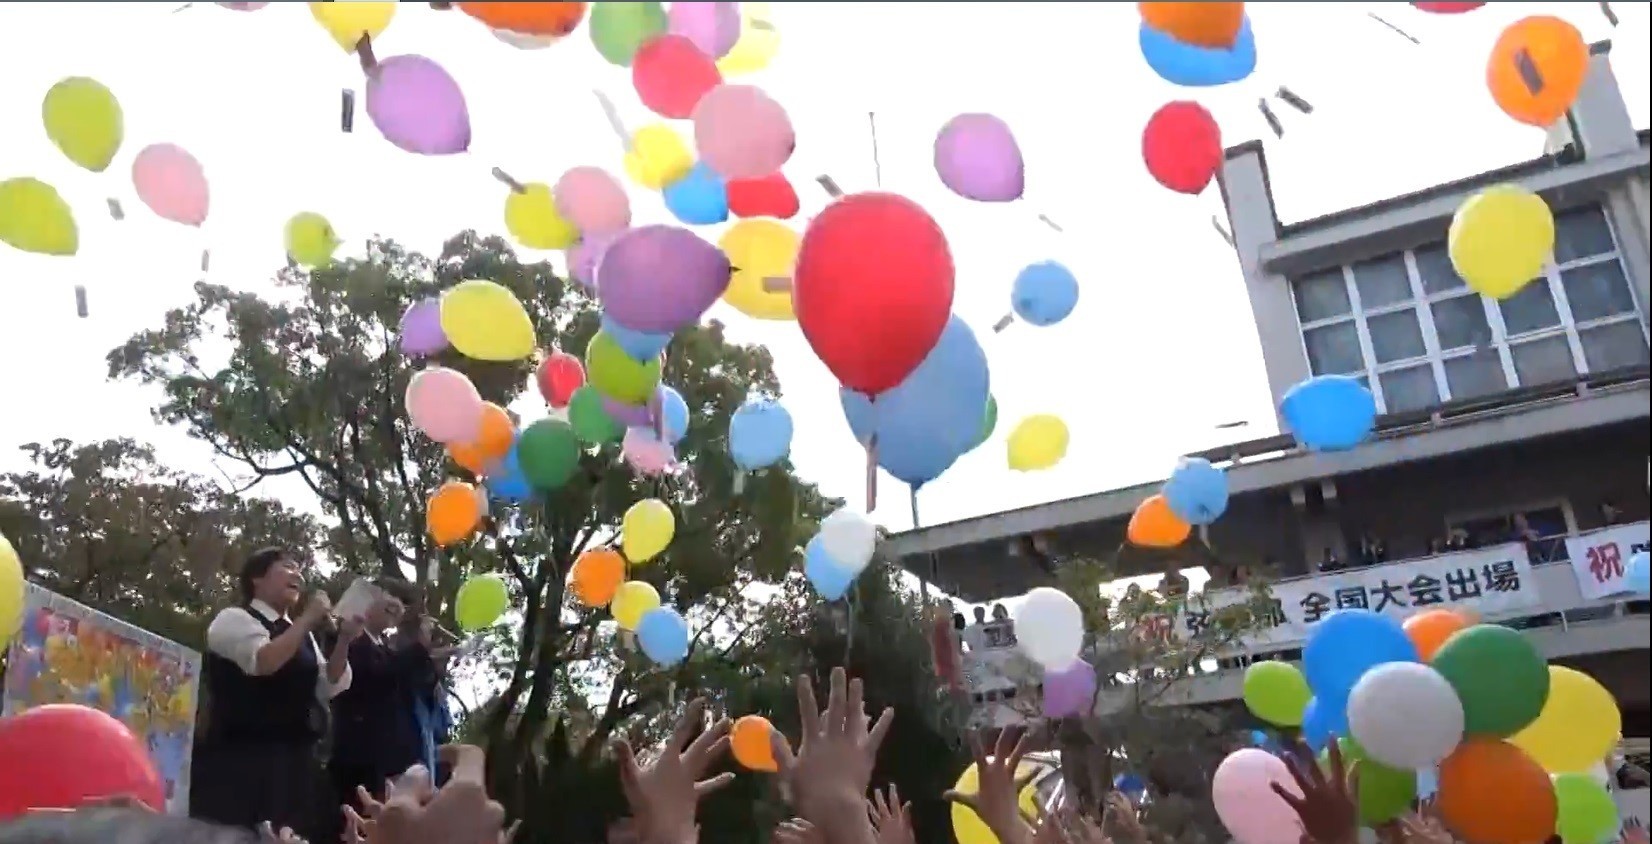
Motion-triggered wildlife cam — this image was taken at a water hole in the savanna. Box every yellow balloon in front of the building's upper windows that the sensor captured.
[1446,185,1555,299]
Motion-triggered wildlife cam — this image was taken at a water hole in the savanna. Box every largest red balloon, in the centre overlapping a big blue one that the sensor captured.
[791,193,953,396]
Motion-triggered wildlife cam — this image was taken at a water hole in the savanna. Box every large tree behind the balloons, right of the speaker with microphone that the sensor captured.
[109,231,829,841]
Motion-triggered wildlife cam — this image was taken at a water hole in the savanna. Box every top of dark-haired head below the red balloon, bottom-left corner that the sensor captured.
[0,808,258,844]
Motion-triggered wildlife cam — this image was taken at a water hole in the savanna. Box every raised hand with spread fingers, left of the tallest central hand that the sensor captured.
[613,699,733,844]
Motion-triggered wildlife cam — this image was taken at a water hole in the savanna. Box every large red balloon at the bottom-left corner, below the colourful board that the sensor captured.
[0,704,167,821]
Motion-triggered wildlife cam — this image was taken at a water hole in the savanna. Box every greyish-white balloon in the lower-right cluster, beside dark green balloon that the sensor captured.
[1348,662,1462,770]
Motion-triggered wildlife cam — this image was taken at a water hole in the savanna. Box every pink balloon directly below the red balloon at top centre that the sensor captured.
[694,84,798,180]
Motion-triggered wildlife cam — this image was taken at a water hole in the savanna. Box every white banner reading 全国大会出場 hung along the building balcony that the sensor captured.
[1176,542,1541,647]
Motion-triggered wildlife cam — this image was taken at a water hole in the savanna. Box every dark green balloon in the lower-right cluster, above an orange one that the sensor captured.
[1429,624,1550,738]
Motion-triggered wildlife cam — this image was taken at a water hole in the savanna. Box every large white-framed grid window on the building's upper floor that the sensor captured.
[1292,205,1652,413]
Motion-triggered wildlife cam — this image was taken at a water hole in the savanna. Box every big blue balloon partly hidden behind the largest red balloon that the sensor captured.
[838,317,991,489]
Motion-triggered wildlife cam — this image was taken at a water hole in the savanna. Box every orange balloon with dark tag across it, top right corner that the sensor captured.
[1485,15,1589,129]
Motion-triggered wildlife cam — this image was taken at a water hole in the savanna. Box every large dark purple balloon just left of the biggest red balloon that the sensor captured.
[596,226,730,334]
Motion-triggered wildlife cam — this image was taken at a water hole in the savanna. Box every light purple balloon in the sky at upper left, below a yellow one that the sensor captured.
[367,56,471,155]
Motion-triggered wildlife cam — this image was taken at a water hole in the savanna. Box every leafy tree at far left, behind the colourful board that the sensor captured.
[0,439,320,647]
